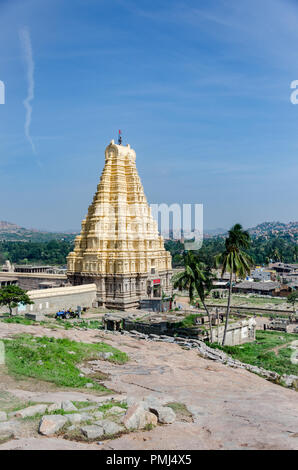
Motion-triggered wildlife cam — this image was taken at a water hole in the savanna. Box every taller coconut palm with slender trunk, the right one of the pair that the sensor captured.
[215,224,253,346]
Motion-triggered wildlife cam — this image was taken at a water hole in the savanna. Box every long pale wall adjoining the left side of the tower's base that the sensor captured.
[16,284,96,314]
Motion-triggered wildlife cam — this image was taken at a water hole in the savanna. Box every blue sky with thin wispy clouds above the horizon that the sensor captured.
[0,0,298,230]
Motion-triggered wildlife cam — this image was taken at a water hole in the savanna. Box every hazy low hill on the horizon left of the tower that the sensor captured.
[0,220,77,242]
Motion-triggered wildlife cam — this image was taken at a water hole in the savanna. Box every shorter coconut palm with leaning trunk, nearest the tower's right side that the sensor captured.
[173,251,214,343]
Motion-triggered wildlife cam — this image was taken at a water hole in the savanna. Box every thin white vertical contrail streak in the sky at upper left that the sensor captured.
[19,28,36,153]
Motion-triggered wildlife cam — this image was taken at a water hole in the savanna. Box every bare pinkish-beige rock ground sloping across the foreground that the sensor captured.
[0,324,298,449]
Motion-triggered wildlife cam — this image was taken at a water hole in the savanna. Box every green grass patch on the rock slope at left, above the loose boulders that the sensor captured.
[4,334,128,391]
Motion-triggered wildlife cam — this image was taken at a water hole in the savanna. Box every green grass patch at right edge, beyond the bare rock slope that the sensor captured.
[209,331,298,375]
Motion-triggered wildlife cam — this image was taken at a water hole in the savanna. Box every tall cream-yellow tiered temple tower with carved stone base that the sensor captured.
[67,140,172,309]
